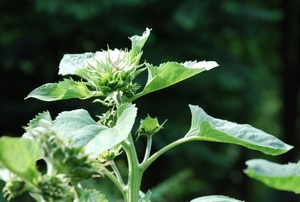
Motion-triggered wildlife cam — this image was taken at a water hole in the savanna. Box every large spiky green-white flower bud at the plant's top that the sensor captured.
[76,49,145,105]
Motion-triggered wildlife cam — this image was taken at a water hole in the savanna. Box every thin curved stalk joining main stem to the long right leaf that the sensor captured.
[140,137,197,172]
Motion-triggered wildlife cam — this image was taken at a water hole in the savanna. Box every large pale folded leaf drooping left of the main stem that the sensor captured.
[54,104,137,157]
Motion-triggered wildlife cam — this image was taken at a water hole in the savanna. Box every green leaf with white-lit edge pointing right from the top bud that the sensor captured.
[131,61,218,100]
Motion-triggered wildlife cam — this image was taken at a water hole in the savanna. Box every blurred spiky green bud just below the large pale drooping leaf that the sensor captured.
[31,119,104,181]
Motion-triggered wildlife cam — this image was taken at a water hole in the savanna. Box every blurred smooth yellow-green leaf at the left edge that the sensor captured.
[0,136,40,185]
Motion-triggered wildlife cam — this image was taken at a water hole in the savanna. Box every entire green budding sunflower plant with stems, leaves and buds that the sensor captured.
[0,29,292,202]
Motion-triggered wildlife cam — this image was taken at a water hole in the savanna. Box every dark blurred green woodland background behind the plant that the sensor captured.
[0,0,300,202]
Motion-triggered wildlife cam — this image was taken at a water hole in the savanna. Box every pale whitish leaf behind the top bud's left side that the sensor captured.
[58,53,94,76]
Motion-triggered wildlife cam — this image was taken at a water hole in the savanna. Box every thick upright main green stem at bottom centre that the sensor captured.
[122,134,143,202]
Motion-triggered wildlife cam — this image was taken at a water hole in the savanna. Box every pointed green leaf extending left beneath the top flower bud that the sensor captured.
[25,79,93,101]
